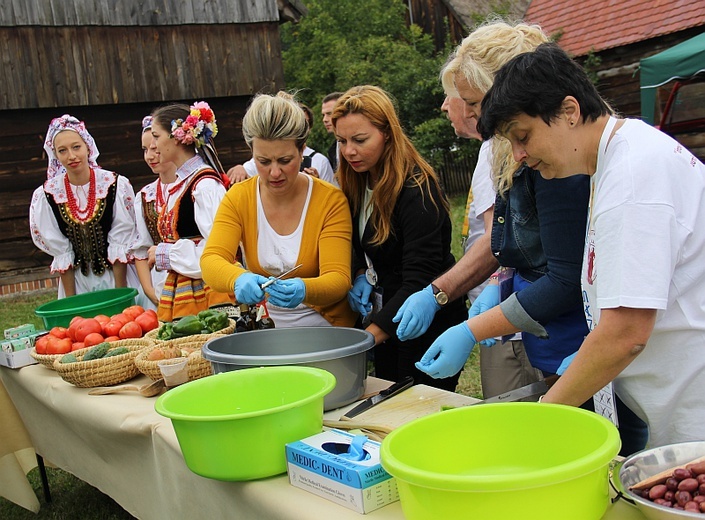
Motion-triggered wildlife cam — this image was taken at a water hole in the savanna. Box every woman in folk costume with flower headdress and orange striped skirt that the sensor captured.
[149,101,234,321]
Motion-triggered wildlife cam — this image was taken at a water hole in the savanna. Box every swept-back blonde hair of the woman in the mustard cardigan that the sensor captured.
[242,91,309,150]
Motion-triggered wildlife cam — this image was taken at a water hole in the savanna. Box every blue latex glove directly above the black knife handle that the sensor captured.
[416,322,477,379]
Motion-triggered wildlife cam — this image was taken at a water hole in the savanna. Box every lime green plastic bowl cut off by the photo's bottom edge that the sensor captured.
[381,403,620,520]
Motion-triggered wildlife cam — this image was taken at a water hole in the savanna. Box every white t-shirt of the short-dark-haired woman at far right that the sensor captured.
[582,119,705,446]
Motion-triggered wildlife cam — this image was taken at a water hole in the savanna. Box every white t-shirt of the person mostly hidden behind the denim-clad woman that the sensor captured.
[465,141,496,302]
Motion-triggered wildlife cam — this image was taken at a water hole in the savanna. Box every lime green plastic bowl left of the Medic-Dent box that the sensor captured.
[154,366,335,480]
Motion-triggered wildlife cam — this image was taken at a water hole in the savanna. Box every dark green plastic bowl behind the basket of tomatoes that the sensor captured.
[34,287,137,329]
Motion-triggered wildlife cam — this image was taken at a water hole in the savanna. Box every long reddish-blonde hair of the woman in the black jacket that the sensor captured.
[331,85,449,245]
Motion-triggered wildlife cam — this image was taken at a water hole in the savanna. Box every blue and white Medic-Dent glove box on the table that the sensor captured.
[286,430,399,514]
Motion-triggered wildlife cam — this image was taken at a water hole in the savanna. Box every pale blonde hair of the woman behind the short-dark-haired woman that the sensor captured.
[440,19,549,194]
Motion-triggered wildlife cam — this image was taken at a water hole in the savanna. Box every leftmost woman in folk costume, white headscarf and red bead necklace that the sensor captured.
[29,114,139,298]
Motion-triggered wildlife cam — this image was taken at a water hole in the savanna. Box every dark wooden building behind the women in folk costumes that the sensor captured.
[0,0,306,294]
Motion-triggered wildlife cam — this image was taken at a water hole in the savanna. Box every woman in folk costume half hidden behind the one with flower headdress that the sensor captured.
[130,116,176,310]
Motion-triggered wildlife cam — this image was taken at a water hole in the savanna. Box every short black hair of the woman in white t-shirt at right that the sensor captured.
[477,43,611,140]
